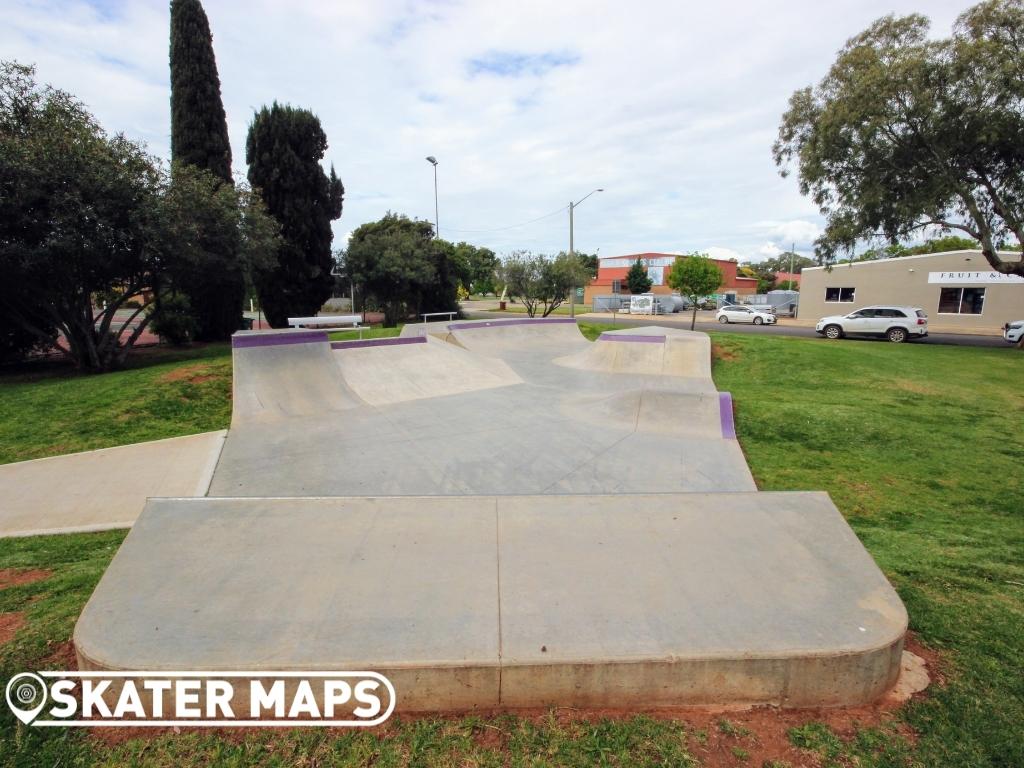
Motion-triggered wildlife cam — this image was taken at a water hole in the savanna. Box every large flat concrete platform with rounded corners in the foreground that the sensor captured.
[74,493,907,712]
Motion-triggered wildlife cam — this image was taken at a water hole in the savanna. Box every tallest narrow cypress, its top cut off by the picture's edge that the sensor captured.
[171,0,245,341]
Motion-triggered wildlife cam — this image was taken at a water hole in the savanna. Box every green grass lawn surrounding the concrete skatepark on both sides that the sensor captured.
[0,331,1024,768]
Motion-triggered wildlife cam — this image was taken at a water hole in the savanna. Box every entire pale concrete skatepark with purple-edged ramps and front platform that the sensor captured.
[64,318,907,712]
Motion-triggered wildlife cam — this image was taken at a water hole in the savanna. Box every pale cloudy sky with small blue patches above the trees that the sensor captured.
[0,0,968,260]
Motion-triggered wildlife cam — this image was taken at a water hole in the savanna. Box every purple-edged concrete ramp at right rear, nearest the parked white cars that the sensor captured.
[554,326,714,386]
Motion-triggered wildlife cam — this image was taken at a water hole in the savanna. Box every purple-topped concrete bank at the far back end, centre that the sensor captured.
[447,317,590,356]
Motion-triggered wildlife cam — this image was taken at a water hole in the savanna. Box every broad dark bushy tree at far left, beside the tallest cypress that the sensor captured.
[0,62,273,370]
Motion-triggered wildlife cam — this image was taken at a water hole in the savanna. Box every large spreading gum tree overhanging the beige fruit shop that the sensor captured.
[773,0,1024,274]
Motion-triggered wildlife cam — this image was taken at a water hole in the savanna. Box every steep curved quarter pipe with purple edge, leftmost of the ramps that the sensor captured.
[231,331,360,428]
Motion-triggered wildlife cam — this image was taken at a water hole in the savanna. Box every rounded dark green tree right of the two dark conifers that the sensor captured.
[344,213,459,326]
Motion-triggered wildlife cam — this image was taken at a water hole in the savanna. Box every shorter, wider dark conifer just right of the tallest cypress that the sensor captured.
[246,101,345,328]
